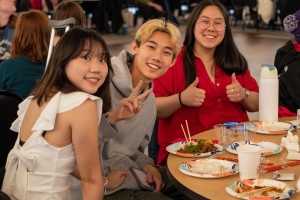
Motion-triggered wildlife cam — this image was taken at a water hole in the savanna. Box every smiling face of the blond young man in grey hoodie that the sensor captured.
[131,31,175,84]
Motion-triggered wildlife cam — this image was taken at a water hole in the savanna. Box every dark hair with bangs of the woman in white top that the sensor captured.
[32,28,113,113]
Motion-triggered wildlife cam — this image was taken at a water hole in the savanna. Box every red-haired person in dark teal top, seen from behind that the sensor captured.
[0,10,50,98]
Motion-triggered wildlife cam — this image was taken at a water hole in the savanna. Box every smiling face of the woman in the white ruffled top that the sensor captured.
[66,47,108,94]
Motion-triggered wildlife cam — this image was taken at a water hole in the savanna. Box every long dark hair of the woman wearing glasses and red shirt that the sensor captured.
[183,0,248,87]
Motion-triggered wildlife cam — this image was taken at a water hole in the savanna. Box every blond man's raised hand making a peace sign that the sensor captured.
[108,81,152,124]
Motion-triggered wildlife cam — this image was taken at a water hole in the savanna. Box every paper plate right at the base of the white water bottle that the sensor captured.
[248,122,291,135]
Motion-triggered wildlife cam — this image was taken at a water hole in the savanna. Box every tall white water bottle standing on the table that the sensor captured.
[259,64,279,122]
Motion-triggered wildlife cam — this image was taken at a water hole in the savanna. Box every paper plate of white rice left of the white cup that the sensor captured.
[179,159,239,178]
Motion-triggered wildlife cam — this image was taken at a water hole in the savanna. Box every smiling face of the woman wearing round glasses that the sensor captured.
[194,6,226,49]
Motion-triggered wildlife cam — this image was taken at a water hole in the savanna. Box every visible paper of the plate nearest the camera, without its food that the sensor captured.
[226,179,295,199]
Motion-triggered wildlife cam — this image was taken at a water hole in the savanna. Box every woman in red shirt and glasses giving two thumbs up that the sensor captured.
[154,0,258,164]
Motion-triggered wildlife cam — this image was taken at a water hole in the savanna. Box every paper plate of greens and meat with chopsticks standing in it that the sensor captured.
[166,139,223,158]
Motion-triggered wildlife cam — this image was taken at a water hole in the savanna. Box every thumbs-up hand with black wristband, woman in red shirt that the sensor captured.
[181,77,205,107]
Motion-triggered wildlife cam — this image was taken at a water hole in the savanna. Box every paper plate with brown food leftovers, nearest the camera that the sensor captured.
[226,179,295,199]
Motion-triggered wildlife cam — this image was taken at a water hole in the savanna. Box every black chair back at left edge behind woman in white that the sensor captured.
[0,90,23,167]
